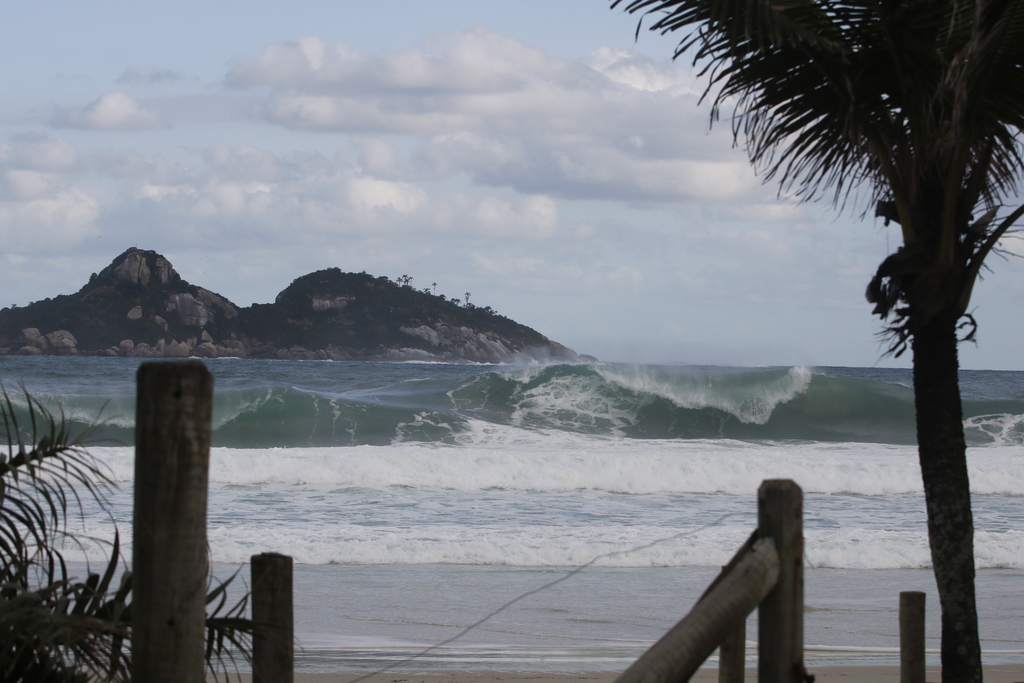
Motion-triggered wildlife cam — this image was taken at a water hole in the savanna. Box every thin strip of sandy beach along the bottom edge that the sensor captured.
[210,664,1024,683]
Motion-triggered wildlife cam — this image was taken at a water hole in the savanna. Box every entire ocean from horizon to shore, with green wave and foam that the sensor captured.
[0,356,1024,672]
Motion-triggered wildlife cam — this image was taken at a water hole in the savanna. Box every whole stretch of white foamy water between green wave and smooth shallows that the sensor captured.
[72,432,1024,568]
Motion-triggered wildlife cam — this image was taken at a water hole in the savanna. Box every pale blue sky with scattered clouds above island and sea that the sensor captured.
[0,0,1024,370]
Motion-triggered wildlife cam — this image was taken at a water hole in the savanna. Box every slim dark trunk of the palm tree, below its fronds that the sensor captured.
[913,315,982,683]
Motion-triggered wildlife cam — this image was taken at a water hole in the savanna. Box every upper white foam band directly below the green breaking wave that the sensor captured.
[88,438,1024,496]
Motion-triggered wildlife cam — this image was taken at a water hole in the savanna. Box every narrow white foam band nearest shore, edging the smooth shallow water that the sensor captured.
[61,520,1024,569]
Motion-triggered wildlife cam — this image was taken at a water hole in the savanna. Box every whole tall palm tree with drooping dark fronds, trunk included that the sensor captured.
[611,0,1024,681]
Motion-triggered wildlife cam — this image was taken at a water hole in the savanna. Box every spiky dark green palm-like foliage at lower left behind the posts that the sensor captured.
[0,391,252,683]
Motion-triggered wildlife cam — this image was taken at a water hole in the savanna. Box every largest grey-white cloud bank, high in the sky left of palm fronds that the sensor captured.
[225,28,759,203]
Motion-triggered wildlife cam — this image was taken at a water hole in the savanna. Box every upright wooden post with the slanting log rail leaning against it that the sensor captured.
[758,479,807,683]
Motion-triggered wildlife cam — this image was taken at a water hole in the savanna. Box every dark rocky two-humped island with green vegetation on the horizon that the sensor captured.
[0,249,577,362]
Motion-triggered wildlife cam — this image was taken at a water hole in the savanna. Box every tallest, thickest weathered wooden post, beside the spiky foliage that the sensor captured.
[131,360,213,683]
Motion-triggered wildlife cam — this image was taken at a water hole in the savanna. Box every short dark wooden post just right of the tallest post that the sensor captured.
[250,553,295,683]
